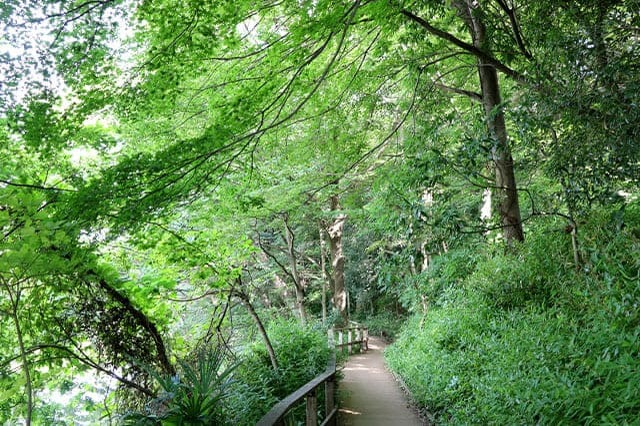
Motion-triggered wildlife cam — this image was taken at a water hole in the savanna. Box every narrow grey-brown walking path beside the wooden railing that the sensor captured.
[338,337,426,426]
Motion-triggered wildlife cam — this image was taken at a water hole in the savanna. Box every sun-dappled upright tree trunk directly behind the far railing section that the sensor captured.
[327,195,349,324]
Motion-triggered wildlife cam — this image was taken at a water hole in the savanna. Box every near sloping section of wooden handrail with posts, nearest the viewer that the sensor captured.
[257,353,338,426]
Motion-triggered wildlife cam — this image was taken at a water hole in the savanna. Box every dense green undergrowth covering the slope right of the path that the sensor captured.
[386,203,640,425]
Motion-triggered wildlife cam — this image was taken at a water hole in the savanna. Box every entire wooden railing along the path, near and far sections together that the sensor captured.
[257,324,369,426]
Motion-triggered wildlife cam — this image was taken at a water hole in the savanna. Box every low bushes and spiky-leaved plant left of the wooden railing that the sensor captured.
[123,319,329,426]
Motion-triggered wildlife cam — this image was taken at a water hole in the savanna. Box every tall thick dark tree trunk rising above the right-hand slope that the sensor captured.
[453,0,524,245]
